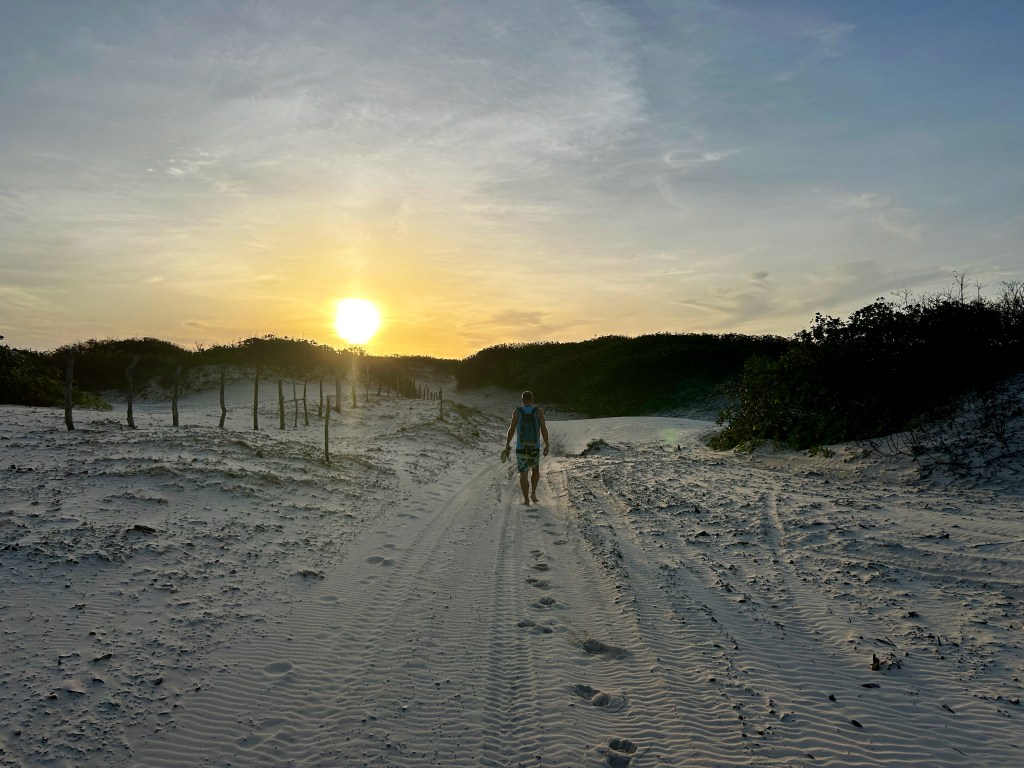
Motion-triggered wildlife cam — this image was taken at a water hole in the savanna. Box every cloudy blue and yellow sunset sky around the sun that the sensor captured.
[0,0,1024,358]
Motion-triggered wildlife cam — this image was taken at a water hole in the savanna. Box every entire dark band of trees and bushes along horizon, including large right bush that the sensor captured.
[8,275,1024,449]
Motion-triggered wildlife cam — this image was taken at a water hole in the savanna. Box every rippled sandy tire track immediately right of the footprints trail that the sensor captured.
[564,460,748,766]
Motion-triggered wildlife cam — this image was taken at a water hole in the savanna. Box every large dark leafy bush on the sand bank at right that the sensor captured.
[712,274,1024,449]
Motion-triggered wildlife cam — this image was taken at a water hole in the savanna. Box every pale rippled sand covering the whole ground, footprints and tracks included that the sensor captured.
[0,385,1024,768]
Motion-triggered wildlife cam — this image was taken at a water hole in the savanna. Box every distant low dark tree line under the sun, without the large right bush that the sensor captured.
[0,334,791,417]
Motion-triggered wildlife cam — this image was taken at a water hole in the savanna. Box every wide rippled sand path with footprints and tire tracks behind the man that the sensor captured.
[133,442,655,766]
